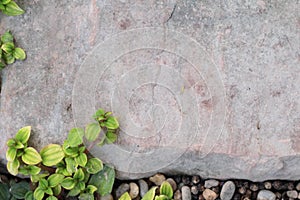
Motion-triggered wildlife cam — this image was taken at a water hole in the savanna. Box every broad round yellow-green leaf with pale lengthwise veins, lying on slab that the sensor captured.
[41,144,65,167]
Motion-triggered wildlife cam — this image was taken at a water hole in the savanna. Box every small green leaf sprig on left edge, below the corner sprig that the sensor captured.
[0,30,26,69]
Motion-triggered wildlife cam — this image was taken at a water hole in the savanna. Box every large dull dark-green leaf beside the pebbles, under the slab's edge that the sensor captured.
[89,165,115,196]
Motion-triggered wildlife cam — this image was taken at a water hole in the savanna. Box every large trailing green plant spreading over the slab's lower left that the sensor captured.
[6,109,119,200]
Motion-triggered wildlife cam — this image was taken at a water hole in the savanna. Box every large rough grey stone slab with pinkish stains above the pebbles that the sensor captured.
[0,0,300,181]
